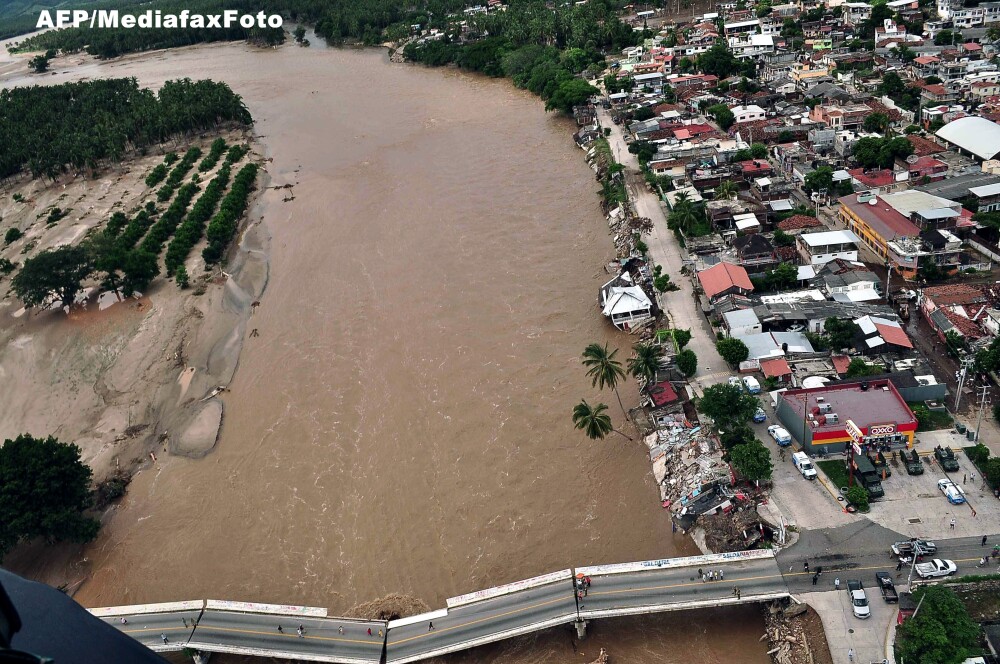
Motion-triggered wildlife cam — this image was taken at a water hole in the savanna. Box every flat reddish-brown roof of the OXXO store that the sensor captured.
[781,380,917,433]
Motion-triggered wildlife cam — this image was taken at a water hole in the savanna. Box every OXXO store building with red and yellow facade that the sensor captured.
[777,380,917,452]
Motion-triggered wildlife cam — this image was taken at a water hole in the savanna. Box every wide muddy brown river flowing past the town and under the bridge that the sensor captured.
[3,39,768,664]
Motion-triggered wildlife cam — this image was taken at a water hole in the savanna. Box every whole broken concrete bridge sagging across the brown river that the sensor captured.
[90,551,789,664]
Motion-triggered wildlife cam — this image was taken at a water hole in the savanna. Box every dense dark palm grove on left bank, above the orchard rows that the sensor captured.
[0,78,253,178]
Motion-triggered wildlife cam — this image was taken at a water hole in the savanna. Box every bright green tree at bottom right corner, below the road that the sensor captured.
[895,586,980,664]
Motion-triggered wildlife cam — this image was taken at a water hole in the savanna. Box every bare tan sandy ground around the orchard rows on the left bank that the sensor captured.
[0,131,268,576]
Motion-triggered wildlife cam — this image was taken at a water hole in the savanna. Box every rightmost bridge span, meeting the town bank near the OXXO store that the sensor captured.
[580,558,788,618]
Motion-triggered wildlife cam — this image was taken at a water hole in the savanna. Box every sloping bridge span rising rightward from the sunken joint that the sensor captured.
[386,580,576,664]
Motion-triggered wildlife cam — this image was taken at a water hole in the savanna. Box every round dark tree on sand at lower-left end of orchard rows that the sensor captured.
[11,246,92,307]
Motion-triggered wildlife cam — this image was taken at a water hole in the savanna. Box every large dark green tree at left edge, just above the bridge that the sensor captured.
[0,434,100,559]
